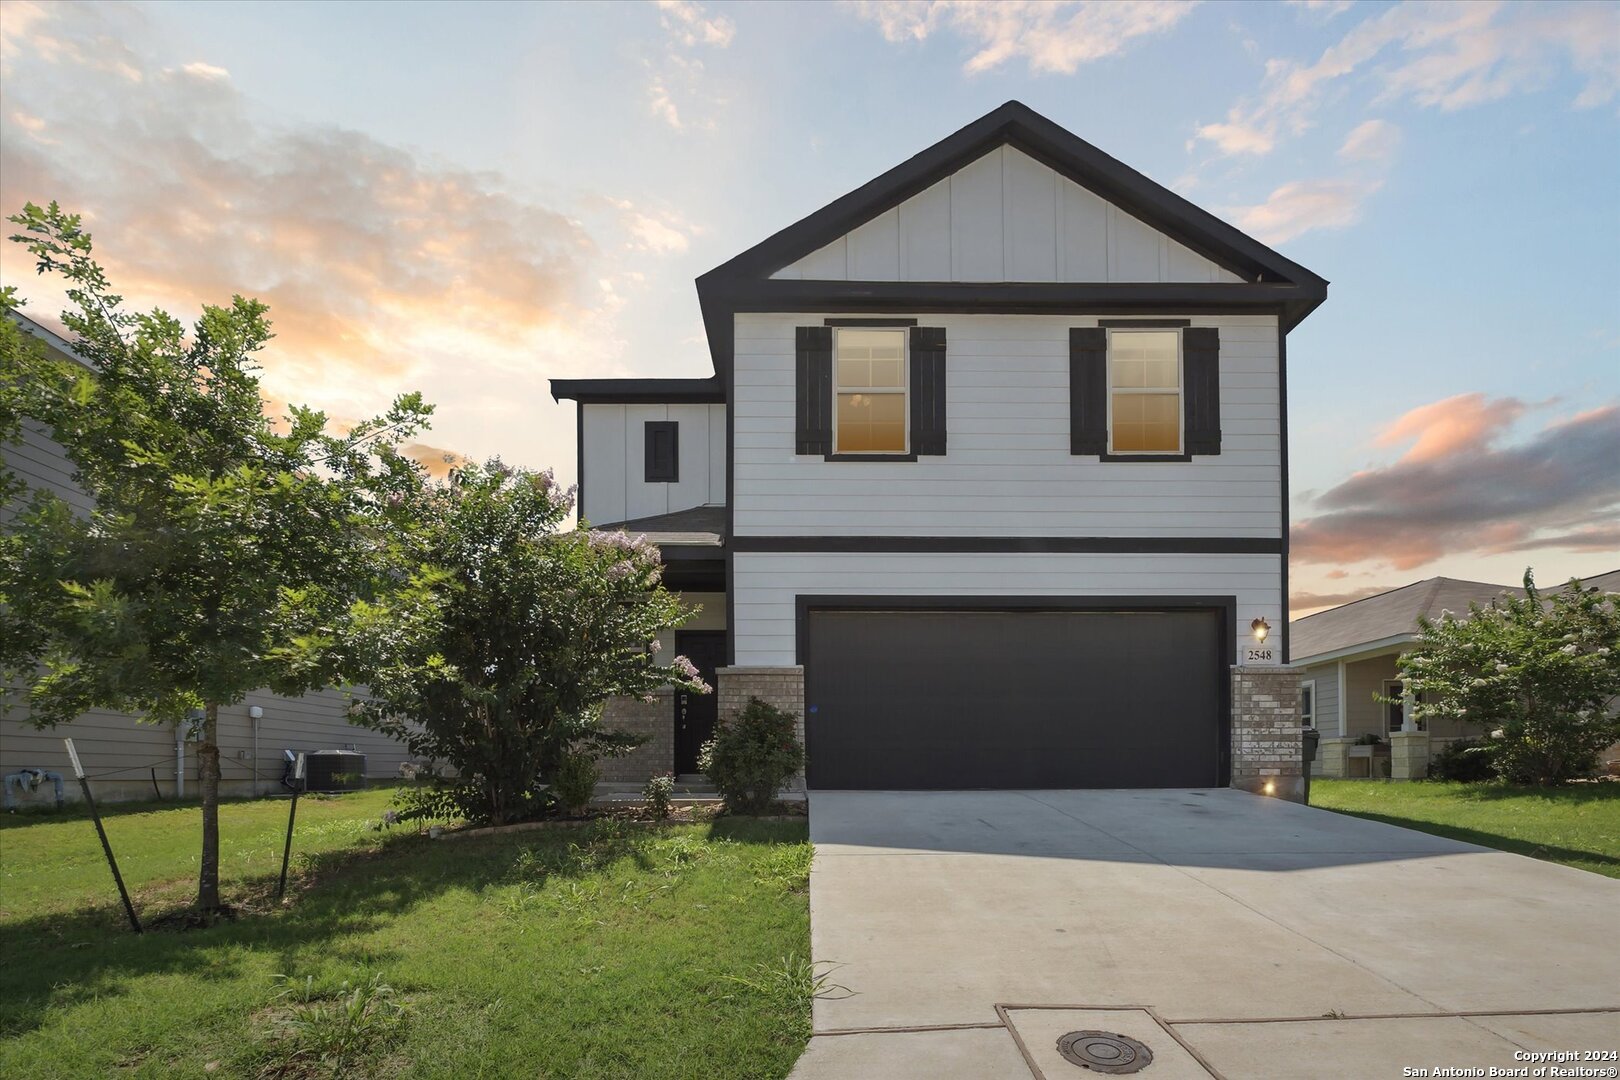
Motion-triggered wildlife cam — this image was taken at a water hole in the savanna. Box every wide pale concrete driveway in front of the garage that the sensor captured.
[794,789,1620,1080]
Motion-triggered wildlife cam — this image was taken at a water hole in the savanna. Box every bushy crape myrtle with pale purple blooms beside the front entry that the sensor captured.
[353,460,708,823]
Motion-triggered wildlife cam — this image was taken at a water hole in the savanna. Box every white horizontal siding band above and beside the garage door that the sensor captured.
[732,551,1283,667]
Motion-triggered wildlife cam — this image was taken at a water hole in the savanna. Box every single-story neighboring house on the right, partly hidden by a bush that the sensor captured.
[1290,570,1620,780]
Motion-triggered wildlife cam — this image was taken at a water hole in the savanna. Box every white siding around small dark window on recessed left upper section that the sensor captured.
[580,405,729,523]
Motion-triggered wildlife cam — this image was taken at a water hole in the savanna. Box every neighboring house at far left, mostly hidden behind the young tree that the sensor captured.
[0,313,410,805]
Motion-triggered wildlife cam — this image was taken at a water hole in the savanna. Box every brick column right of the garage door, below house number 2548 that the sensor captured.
[1231,667,1304,803]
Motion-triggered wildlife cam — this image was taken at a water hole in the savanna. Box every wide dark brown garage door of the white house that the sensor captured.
[805,609,1225,790]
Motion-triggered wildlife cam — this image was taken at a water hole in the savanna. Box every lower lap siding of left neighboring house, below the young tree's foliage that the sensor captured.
[0,690,410,803]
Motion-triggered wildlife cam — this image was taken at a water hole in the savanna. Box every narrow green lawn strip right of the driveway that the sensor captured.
[1311,780,1620,878]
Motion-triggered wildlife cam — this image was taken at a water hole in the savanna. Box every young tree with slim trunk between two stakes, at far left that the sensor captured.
[0,202,431,921]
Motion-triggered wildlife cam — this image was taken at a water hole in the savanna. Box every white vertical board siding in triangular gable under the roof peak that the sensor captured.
[773,146,1243,282]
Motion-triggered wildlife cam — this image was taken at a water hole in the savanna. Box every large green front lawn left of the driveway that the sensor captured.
[0,792,815,1080]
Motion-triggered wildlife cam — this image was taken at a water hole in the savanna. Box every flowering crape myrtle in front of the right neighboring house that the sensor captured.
[1398,570,1620,784]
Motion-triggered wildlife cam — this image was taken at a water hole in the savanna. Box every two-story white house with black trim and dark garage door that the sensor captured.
[552,102,1327,793]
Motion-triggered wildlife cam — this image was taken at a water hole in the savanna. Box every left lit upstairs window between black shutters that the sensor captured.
[833,327,909,453]
